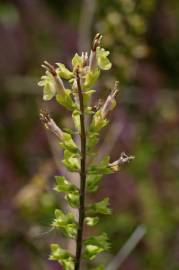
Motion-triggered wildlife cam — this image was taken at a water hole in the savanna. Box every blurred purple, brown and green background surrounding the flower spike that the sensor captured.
[0,0,179,270]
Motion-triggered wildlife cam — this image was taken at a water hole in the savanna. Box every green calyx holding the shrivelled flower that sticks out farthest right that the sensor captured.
[88,156,112,175]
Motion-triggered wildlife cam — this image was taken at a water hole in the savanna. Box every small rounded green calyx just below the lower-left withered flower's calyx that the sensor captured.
[63,150,80,172]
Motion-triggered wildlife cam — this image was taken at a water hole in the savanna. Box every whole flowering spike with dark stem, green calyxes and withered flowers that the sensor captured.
[38,34,133,270]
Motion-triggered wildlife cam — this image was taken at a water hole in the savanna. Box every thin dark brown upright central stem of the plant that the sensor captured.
[75,69,86,270]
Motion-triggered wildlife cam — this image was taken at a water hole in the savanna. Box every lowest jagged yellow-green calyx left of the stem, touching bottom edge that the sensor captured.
[49,244,74,270]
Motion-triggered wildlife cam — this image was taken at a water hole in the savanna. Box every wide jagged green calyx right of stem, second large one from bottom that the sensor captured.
[87,198,111,215]
